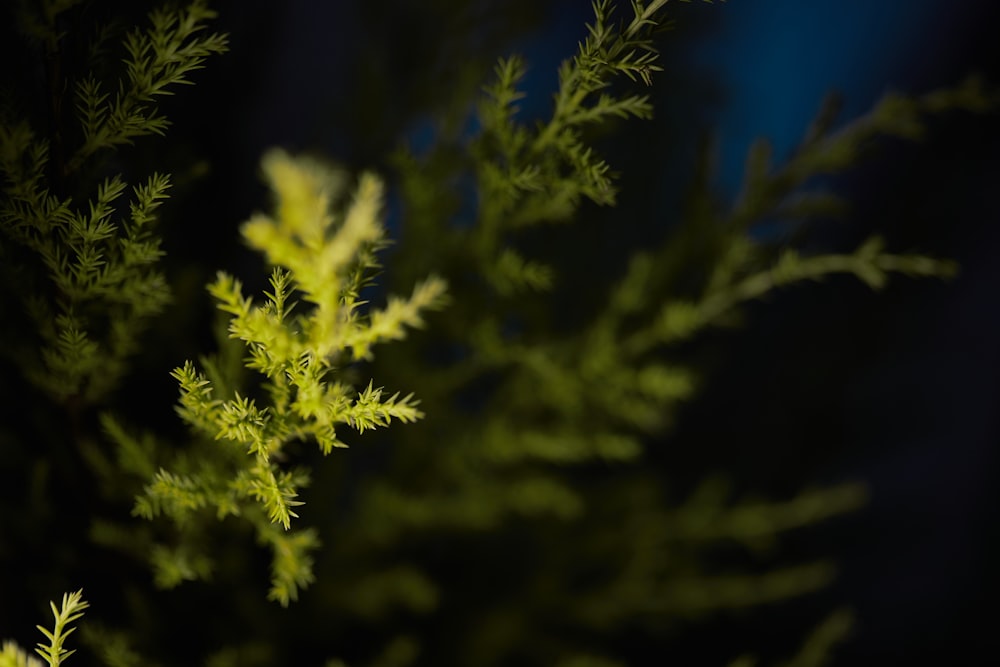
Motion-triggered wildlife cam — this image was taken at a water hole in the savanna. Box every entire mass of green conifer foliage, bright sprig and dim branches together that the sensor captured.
[0,0,995,667]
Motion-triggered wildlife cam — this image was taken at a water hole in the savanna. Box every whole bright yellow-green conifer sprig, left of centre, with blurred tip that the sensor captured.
[121,151,445,605]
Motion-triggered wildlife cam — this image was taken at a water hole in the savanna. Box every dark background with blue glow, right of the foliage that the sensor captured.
[690,0,1000,664]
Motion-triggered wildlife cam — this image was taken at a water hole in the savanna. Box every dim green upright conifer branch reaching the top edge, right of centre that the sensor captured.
[464,0,716,294]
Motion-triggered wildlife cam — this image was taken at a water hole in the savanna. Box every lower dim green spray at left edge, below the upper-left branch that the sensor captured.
[3,163,169,403]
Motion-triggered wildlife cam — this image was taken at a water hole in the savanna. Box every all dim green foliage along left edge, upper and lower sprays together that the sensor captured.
[0,1,226,405]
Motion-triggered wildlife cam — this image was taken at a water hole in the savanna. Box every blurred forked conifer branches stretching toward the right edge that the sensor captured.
[600,77,1000,357]
